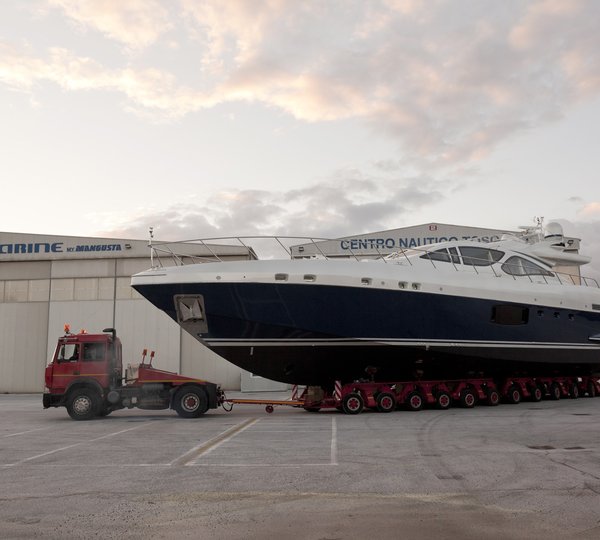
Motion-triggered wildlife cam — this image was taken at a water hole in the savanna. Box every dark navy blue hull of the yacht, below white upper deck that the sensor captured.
[135,283,600,384]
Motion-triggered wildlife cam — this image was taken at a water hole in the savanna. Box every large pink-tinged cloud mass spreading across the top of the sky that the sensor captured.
[0,0,600,165]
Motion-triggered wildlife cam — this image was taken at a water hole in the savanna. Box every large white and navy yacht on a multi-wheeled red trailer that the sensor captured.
[131,224,600,385]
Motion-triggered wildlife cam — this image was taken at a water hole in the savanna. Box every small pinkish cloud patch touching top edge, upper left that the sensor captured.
[48,0,173,49]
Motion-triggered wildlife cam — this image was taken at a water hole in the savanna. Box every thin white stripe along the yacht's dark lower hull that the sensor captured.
[202,338,600,350]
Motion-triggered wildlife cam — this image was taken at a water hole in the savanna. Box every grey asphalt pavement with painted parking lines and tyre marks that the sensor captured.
[0,394,600,540]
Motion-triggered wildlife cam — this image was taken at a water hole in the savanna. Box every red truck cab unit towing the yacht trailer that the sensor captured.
[43,325,223,420]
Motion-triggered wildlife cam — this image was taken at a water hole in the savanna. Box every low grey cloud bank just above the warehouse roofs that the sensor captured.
[97,170,455,241]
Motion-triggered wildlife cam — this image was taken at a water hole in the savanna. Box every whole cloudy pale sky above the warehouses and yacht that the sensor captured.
[0,0,600,270]
